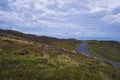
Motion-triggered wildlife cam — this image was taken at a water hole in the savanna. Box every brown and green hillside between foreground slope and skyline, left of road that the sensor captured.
[0,30,81,50]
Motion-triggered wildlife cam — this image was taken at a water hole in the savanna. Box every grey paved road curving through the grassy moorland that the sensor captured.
[76,42,120,68]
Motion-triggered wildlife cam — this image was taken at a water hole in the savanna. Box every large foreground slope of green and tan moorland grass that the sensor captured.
[0,29,120,80]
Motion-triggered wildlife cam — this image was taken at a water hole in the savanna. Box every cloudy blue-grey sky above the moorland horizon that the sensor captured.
[0,0,120,40]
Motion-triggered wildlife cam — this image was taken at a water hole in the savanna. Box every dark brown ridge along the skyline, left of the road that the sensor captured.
[0,29,78,43]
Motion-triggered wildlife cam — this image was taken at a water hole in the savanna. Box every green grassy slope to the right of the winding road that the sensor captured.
[89,41,120,62]
